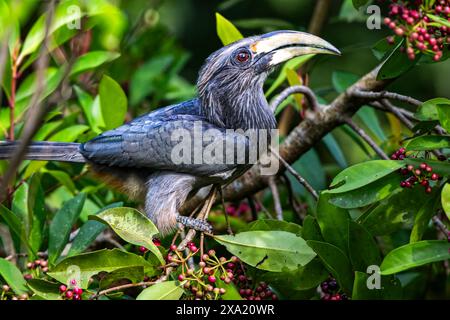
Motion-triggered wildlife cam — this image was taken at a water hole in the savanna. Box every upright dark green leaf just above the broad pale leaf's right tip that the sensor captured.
[316,192,350,252]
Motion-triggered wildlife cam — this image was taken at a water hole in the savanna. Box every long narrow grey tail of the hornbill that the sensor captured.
[0,141,86,162]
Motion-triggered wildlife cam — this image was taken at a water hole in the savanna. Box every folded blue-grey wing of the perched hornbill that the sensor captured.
[80,114,249,176]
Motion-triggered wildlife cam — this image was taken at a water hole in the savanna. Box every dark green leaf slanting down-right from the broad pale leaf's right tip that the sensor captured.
[307,240,353,294]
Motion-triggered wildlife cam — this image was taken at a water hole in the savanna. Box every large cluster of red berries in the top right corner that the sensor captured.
[384,0,450,61]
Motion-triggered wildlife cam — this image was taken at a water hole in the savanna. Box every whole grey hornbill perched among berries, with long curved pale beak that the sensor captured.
[0,31,340,234]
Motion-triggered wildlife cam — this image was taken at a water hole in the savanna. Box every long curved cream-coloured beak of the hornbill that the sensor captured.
[250,30,341,66]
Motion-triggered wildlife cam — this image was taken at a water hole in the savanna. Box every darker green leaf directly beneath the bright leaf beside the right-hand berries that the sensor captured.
[325,172,402,209]
